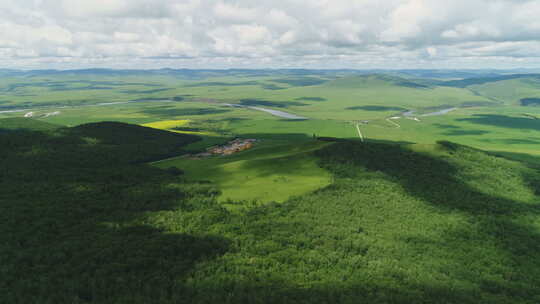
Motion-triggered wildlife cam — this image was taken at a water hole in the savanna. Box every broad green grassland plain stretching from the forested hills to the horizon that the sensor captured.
[0,71,540,201]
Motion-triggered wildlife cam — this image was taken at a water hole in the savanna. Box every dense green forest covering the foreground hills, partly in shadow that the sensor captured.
[0,120,540,304]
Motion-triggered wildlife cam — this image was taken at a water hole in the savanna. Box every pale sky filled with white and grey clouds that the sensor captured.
[0,0,540,69]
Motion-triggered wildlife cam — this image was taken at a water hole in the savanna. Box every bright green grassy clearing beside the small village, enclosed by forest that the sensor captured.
[155,141,330,203]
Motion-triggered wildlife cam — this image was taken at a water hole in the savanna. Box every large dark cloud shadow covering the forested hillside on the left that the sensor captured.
[0,129,230,303]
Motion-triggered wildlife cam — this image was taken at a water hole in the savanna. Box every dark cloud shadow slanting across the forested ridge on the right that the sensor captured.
[319,142,540,301]
